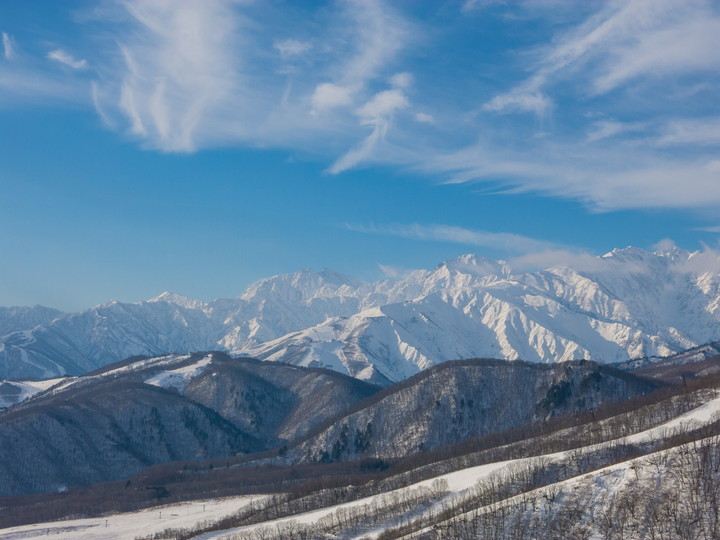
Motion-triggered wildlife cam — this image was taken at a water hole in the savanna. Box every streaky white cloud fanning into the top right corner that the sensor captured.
[484,0,720,115]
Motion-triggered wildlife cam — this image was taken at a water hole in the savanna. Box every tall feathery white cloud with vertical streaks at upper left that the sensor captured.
[96,0,241,152]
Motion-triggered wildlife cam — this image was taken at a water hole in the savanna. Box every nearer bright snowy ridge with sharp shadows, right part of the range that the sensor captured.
[243,248,720,381]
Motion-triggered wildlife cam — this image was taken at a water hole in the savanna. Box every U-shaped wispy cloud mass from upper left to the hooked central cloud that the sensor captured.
[86,0,412,162]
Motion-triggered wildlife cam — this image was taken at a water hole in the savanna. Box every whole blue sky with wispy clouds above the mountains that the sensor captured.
[0,0,720,310]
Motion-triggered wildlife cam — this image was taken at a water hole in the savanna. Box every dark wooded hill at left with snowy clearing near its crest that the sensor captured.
[0,353,378,495]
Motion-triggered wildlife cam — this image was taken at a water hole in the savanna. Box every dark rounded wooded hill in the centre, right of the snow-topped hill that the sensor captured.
[284,359,661,463]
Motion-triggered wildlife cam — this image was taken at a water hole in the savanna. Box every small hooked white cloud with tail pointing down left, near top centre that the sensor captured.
[328,89,410,174]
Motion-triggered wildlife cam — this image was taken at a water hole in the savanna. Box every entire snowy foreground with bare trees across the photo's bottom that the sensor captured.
[0,380,720,540]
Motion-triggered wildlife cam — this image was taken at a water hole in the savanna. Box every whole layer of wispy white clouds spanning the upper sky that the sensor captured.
[0,0,720,215]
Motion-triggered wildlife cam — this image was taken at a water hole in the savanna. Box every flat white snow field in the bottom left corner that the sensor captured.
[0,496,263,540]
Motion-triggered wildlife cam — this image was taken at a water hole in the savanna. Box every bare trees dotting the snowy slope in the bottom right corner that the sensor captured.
[410,436,720,540]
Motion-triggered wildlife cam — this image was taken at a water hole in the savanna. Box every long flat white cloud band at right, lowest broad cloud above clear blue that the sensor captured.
[420,141,720,211]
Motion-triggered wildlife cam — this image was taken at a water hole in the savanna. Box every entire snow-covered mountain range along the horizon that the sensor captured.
[0,247,720,383]
